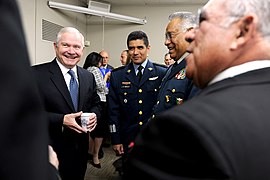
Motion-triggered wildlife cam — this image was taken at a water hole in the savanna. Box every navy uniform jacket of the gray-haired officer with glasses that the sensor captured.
[152,59,199,118]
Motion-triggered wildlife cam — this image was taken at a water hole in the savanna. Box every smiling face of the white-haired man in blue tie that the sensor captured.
[54,32,84,69]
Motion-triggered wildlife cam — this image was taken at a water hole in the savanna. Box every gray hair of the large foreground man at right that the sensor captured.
[216,0,270,41]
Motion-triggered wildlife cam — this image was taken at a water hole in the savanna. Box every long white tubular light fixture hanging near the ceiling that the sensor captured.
[48,1,147,24]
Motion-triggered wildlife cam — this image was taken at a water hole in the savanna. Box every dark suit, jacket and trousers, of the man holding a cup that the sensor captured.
[33,59,100,179]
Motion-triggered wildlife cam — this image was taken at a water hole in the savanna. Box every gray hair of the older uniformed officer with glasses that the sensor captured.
[169,11,196,32]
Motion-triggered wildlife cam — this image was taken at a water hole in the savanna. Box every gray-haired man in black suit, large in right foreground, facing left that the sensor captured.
[125,0,270,180]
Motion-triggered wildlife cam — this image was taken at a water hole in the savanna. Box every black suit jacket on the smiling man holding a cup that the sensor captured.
[33,59,100,144]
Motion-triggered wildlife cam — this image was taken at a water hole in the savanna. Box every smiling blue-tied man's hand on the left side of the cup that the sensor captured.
[63,111,87,133]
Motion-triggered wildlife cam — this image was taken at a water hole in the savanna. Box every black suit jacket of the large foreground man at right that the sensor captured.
[125,68,270,180]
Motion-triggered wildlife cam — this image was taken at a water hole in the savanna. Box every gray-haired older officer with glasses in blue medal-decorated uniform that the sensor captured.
[152,12,198,118]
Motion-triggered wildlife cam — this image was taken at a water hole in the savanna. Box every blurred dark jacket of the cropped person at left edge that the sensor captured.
[0,0,57,180]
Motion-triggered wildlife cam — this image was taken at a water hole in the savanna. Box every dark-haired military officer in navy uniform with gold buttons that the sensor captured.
[108,31,167,155]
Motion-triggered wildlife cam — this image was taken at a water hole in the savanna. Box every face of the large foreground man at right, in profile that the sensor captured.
[185,0,239,88]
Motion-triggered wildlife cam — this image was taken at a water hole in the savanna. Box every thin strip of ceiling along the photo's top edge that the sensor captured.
[79,0,208,6]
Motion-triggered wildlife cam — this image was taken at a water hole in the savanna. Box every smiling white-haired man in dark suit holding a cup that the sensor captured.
[33,27,100,180]
